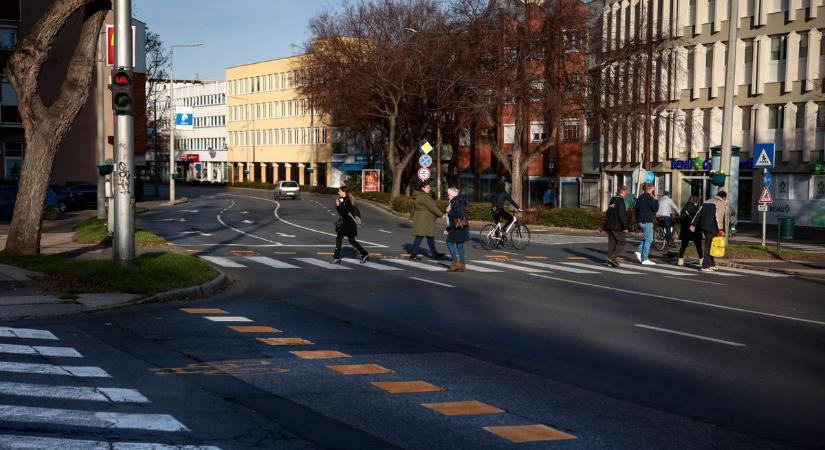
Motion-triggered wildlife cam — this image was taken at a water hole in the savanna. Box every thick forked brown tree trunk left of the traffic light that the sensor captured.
[5,0,112,255]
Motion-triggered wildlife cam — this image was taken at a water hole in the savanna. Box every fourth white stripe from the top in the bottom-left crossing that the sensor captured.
[0,382,150,403]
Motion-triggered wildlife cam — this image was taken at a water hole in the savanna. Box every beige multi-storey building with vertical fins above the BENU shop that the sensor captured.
[598,0,825,226]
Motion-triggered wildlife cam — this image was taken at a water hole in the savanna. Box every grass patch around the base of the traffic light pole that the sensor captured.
[0,253,218,298]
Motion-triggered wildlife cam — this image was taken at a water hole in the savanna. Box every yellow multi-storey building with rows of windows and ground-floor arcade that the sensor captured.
[226,56,332,185]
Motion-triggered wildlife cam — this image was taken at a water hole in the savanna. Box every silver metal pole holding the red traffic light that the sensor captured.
[112,0,135,266]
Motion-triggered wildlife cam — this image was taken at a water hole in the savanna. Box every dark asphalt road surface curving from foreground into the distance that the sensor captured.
[0,188,825,449]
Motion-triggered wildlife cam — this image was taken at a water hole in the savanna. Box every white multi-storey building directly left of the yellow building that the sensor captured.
[175,81,229,183]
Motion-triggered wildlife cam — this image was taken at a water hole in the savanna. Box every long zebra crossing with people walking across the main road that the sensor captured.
[196,255,788,278]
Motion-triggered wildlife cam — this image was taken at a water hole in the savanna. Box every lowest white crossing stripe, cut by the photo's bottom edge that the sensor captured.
[0,434,221,450]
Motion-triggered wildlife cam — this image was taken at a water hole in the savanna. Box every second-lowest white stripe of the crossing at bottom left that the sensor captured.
[0,405,189,431]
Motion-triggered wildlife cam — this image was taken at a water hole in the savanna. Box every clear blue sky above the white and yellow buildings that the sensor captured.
[132,0,338,80]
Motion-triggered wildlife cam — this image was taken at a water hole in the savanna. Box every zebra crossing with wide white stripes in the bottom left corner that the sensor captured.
[0,326,222,450]
